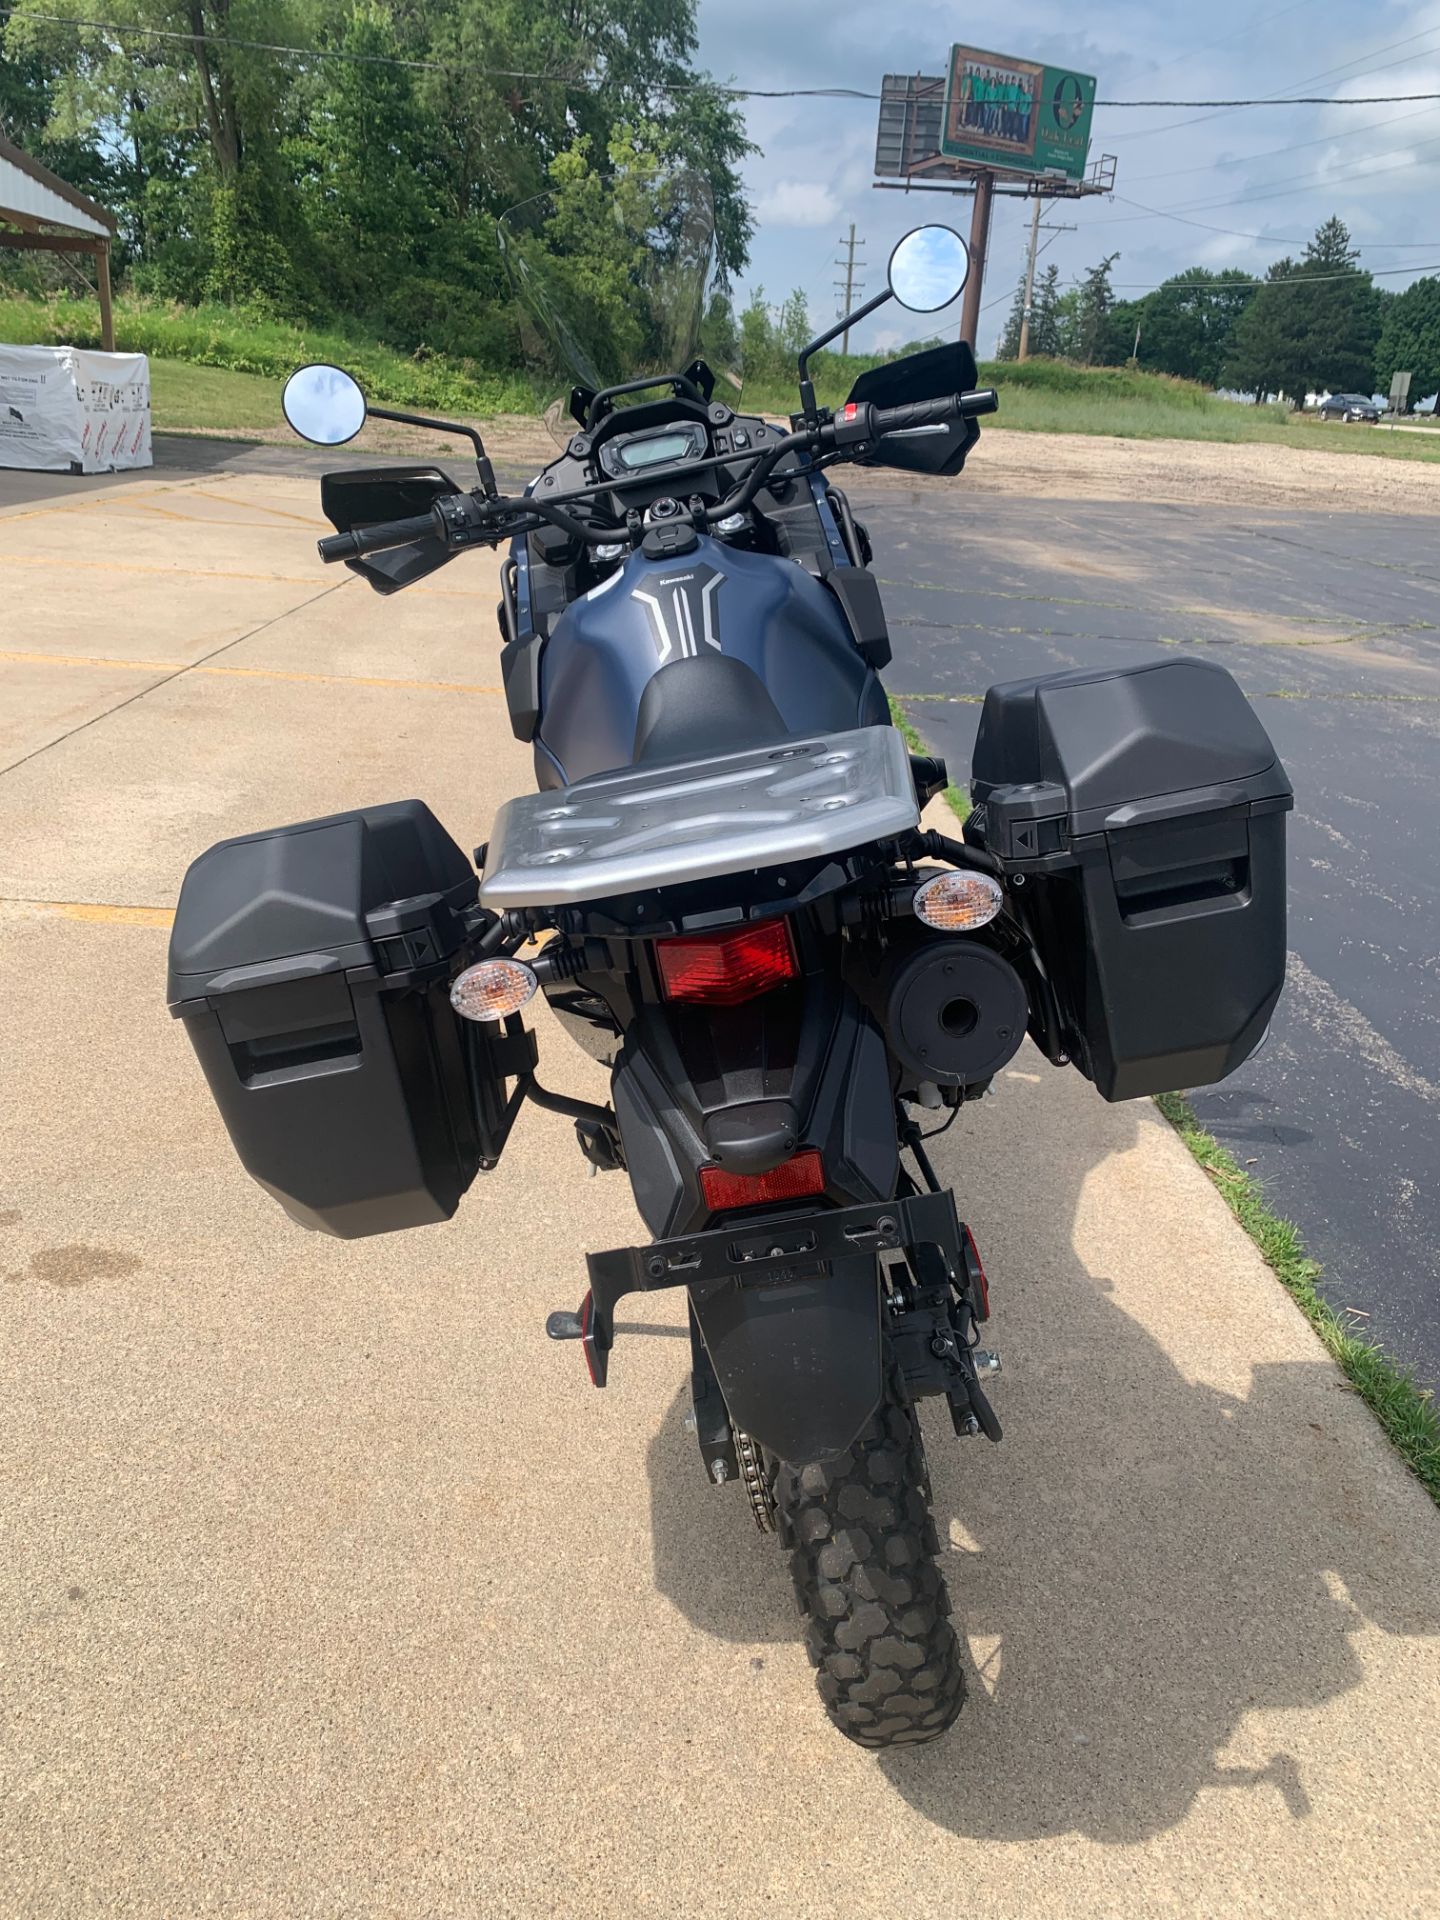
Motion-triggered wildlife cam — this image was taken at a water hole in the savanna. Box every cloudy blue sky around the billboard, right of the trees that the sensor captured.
[699,0,1440,357]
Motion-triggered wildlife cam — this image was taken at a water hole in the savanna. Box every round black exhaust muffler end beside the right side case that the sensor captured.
[885,941,1029,1085]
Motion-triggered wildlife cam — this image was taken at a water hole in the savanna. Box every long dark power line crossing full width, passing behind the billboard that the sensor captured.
[0,6,1440,106]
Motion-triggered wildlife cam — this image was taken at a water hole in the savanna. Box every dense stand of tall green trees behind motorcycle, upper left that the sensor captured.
[0,0,751,353]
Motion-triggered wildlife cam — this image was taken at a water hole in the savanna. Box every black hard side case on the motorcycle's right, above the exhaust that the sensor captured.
[966,659,1292,1100]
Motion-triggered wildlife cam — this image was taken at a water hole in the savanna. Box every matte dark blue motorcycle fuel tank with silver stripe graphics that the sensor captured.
[536,536,889,787]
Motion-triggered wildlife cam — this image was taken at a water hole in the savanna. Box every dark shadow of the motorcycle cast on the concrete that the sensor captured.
[649,1089,1440,1841]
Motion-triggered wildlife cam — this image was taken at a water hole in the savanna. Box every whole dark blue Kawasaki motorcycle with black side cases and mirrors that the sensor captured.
[169,227,1290,1747]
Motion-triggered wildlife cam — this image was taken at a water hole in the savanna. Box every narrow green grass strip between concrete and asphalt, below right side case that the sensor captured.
[1156,1092,1440,1505]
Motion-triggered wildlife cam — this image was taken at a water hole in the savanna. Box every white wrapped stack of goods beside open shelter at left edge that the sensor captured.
[0,346,154,474]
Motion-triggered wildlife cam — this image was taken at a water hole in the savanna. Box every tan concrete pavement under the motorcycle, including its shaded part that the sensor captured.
[0,451,1440,1920]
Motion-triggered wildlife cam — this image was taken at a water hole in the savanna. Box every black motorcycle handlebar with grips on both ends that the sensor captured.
[317,388,1000,563]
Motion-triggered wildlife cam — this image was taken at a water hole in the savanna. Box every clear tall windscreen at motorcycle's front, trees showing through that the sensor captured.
[499,167,739,445]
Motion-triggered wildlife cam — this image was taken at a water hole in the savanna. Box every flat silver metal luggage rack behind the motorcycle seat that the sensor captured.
[480,726,920,910]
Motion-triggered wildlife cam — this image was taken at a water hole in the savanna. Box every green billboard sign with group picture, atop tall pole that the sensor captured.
[941,46,1094,180]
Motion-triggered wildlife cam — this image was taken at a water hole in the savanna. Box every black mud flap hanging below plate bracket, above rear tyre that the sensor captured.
[689,1254,881,1467]
